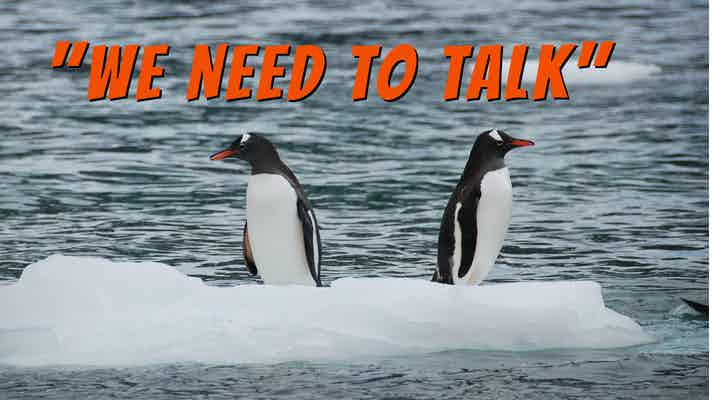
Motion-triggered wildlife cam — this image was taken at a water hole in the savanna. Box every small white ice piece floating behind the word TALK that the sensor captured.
[502,59,662,86]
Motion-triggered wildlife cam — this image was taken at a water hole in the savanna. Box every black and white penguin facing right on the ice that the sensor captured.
[432,129,534,285]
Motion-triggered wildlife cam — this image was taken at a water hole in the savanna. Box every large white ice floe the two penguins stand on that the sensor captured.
[0,255,653,365]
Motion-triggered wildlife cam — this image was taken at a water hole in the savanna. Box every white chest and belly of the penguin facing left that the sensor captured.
[247,174,315,286]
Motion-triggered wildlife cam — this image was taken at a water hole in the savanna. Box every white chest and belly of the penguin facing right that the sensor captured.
[453,167,512,285]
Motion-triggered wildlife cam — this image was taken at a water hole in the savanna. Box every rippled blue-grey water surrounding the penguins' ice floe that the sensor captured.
[0,0,709,399]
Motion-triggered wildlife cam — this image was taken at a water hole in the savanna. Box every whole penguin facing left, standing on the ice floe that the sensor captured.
[210,133,322,286]
